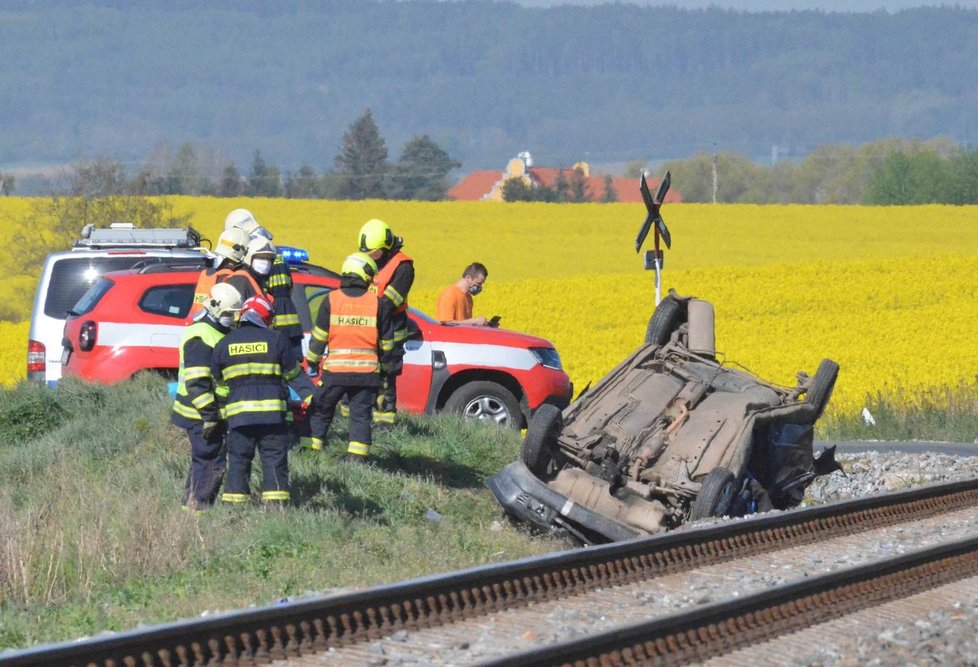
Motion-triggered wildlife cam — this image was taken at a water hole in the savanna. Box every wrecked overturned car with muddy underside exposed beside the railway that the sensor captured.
[487,292,839,544]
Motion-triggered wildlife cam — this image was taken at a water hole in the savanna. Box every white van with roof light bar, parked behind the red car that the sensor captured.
[27,223,206,385]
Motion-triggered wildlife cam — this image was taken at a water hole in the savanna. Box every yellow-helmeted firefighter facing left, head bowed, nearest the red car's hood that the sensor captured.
[359,218,414,425]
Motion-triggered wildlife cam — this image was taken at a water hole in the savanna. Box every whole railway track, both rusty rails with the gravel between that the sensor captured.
[0,480,978,667]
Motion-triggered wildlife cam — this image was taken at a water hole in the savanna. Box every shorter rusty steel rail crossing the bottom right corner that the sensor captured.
[480,537,978,667]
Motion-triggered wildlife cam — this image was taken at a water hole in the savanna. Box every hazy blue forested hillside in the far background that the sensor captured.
[0,0,978,177]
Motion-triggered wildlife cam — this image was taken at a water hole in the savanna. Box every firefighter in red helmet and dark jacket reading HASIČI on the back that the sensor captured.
[211,295,313,506]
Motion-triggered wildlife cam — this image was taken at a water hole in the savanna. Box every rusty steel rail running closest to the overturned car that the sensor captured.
[0,480,978,667]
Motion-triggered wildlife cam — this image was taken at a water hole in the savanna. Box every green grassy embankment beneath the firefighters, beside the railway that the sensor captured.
[0,377,568,648]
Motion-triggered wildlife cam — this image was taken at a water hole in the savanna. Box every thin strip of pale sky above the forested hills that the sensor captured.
[511,0,978,12]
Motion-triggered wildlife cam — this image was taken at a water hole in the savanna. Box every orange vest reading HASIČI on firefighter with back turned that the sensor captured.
[323,290,380,373]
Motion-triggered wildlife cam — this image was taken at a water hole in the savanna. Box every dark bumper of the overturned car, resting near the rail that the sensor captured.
[486,461,640,543]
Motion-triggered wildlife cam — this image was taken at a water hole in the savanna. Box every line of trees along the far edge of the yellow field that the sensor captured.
[7,130,978,205]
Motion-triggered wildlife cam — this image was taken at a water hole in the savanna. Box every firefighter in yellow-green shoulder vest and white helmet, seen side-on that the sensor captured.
[170,283,241,509]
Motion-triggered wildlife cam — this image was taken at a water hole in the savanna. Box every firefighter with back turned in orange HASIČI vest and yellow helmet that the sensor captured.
[306,252,394,463]
